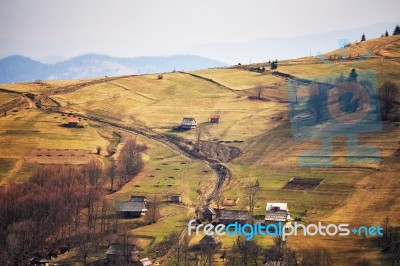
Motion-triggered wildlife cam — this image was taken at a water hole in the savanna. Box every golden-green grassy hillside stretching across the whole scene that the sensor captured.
[0,36,400,265]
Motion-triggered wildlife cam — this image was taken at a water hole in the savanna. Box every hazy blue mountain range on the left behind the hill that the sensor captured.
[0,54,226,84]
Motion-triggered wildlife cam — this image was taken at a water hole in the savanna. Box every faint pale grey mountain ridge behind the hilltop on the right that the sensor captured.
[180,21,396,65]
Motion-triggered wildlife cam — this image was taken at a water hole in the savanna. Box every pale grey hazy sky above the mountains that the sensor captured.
[0,0,400,59]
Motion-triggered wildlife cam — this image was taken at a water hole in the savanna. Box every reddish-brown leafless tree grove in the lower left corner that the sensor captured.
[0,139,146,265]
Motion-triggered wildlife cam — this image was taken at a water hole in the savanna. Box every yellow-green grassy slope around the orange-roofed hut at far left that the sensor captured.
[0,108,107,184]
